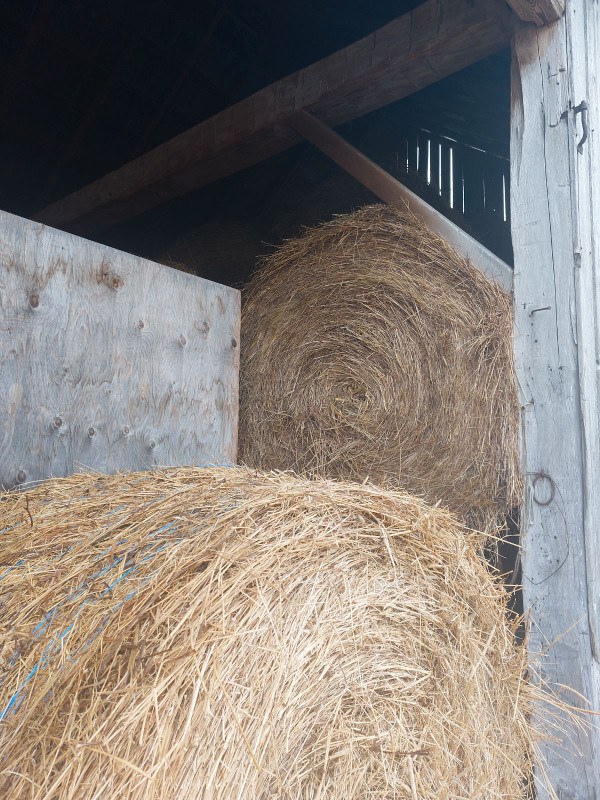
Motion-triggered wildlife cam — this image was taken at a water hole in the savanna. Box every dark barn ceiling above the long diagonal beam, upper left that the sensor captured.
[0,0,419,214]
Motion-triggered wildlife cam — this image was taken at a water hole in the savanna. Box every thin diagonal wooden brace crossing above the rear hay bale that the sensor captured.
[288,111,513,292]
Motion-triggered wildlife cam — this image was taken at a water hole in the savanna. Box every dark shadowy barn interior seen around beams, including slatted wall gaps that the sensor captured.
[0,0,512,287]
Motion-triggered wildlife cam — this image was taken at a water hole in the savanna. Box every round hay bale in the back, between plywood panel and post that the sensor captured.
[239,206,520,529]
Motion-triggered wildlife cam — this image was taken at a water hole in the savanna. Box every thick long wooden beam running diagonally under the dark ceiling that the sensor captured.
[35,0,511,233]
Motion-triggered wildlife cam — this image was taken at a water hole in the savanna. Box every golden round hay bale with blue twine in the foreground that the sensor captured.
[0,468,556,800]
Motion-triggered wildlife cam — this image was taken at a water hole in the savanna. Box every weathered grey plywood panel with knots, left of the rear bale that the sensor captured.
[0,212,240,488]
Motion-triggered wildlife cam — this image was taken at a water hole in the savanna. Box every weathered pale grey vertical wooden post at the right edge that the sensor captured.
[511,0,600,800]
